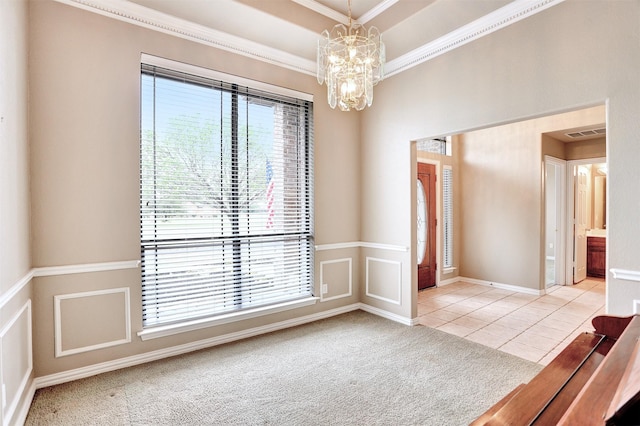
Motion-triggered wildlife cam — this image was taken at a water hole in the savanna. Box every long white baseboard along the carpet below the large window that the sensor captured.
[34,303,361,389]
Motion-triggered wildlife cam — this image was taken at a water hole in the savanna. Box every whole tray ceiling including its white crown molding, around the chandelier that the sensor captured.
[80,0,563,76]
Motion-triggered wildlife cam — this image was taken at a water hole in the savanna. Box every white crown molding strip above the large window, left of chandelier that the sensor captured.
[55,0,316,76]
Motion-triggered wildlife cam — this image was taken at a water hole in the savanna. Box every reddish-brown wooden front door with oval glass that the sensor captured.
[417,163,437,290]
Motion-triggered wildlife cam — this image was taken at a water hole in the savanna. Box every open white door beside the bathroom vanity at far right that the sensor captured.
[573,166,589,283]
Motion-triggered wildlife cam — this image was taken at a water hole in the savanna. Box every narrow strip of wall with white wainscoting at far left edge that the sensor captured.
[0,0,33,424]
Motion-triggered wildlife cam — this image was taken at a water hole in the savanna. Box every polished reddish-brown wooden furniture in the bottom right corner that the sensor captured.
[471,316,640,426]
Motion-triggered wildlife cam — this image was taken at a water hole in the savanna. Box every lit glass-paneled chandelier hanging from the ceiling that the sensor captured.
[317,0,385,111]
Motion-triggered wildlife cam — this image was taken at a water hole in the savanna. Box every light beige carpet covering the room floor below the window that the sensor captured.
[26,311,542,426]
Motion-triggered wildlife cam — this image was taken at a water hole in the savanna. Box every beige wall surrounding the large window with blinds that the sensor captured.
[30,1,360,377]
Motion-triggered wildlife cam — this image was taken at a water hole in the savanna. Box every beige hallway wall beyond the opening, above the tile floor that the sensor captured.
[458,105,606,291]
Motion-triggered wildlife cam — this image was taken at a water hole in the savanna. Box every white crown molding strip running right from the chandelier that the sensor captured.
[383,0,564,77]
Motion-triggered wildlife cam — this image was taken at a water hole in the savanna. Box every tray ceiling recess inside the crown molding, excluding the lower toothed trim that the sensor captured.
[129,0,510,60]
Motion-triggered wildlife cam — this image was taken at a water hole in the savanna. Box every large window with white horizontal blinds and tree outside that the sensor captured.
[140,58,314,328]
